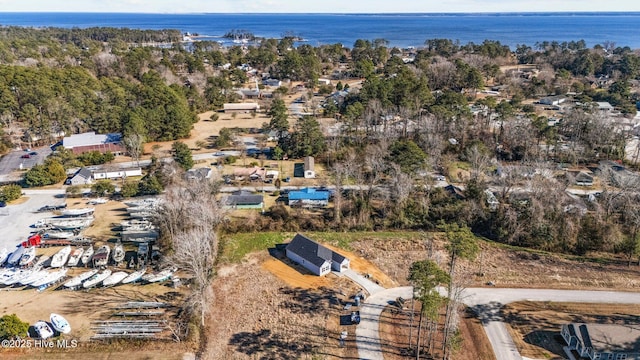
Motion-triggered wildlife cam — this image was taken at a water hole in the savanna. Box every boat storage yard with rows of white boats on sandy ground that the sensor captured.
[0,190,180,341]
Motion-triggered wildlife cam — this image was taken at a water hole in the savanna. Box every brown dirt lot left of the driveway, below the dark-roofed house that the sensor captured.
[205,252,357,359]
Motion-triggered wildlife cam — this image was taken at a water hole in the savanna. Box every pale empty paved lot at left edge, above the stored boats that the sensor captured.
[0,190,65,249]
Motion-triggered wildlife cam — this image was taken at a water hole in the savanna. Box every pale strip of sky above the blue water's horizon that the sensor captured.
[0,0,640,14]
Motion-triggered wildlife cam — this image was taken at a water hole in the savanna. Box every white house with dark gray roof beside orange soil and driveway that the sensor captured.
[285,234,349,276]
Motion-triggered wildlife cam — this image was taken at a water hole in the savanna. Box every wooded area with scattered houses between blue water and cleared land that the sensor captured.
[0,27,640,259]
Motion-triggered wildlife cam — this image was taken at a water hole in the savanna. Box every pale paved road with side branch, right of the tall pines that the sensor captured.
[463,288,640,360]
